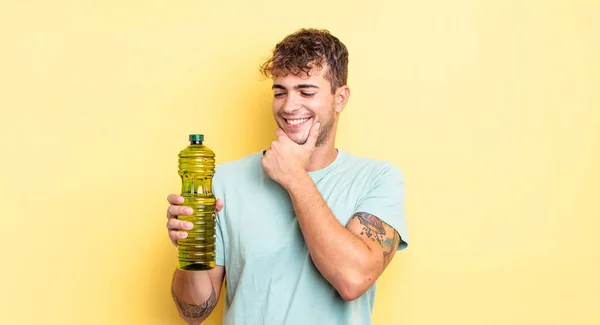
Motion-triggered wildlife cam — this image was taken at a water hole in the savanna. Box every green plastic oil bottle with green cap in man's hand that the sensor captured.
[177,134,216,271]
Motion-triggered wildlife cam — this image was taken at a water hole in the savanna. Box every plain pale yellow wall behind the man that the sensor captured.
[0,0,600,325]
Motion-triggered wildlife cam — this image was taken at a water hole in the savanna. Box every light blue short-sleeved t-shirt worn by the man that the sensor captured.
[213,149,408,325]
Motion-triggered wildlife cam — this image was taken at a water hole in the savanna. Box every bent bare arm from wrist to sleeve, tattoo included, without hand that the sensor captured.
[287,174,401,300]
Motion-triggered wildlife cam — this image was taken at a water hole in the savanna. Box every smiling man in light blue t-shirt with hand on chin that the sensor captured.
[167,29,407,325]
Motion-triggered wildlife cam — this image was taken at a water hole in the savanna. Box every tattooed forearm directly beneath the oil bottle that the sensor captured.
[171,270,217,325]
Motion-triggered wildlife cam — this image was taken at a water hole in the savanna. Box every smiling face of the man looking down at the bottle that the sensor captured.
[273,68,336,146]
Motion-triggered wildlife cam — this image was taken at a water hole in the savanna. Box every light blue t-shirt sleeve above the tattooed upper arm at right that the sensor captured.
[354,163,408,250]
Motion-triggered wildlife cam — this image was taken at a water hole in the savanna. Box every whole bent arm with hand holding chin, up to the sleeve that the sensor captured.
[261,122,401,300]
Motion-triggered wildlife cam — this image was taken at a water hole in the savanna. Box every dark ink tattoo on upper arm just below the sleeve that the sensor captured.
[354,212,402,267]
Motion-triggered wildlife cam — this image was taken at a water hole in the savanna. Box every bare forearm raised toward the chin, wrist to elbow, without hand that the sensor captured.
[287,175,380,300]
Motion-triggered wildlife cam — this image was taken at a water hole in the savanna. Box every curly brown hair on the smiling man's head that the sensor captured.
[260,28,348,94]
